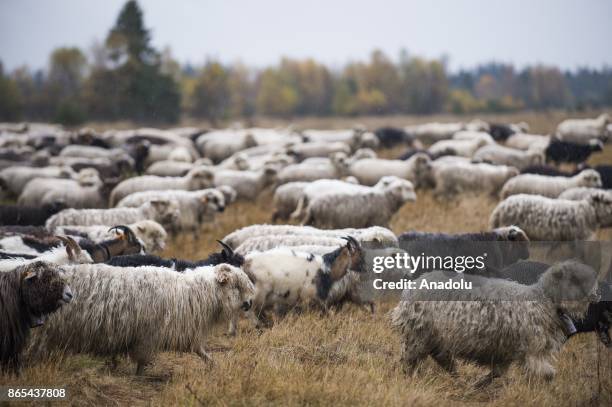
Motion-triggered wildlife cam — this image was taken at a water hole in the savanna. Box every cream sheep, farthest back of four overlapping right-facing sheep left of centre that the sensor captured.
[110,167,214,206]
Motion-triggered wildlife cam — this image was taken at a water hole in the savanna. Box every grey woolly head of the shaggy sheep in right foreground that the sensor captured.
[538,260,599,318]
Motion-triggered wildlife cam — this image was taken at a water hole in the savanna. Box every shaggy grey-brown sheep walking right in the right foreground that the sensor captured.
[391,261,596,387]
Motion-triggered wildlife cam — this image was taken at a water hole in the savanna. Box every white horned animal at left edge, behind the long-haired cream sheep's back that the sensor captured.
[0,236,93,273]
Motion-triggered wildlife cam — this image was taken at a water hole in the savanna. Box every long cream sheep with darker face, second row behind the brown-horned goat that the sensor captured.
[46,200,180,233]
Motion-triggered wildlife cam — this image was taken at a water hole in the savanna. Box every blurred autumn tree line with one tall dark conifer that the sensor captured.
[0,0,612,125]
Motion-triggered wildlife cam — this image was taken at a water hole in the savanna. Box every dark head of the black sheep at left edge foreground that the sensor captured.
[18,261,72,326]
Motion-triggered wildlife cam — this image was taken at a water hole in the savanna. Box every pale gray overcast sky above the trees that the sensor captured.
[0,0,612,69]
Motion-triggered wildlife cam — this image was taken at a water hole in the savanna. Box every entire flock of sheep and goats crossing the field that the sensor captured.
[0,115,612,384]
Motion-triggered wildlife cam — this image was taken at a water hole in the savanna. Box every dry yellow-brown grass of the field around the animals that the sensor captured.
[0,113,612,406]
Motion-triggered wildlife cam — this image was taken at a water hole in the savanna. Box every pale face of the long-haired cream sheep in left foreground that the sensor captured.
[214,264,255,318]
